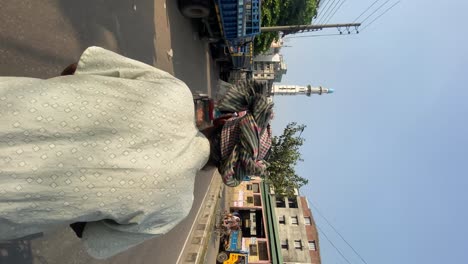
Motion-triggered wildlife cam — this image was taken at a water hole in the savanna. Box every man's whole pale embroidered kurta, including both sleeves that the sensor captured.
[0,47,209,258]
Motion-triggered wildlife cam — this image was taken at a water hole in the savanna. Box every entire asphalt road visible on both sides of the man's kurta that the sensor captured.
[0,0,218,264]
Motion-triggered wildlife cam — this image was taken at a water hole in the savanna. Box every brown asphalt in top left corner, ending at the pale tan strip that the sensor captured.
[0,0,155,78]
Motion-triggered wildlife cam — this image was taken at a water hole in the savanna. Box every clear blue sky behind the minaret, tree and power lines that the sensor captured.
[273,0,468,264]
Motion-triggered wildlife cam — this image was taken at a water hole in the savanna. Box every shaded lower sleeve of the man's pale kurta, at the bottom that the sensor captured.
[82,221,158,259]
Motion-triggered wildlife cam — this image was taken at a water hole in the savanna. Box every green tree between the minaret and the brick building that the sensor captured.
[266,122,309,196]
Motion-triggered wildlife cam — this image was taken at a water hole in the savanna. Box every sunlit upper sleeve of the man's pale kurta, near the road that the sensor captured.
[75,47,178,81]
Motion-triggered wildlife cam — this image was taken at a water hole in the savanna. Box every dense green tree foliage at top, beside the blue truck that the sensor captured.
[254,0,317,54]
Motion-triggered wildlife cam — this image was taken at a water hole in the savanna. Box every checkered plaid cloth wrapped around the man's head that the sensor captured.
[219,83,273,186]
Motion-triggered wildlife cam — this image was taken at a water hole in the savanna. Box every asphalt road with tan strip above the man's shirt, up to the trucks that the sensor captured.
[0,0,217,92]
